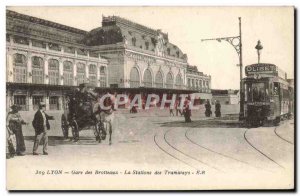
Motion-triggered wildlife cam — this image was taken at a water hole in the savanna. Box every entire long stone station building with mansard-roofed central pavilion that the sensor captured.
[6,10,211,111]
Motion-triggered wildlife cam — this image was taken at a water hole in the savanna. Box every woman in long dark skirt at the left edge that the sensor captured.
[6,104,27,156]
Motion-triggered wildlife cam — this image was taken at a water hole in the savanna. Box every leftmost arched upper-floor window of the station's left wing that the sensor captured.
[13,53,27,83]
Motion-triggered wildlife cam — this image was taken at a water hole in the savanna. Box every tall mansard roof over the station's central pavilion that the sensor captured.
[82,16,187,59]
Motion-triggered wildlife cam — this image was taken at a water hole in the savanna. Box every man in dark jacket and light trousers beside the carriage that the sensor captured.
[32,102,54,155]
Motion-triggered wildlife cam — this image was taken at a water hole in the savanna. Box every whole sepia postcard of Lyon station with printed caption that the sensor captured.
[6,6,296,191]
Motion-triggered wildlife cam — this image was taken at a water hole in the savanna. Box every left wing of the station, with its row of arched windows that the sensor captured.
[6,11,108,111]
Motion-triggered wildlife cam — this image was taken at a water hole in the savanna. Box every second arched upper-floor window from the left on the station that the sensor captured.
[31,56,44,84]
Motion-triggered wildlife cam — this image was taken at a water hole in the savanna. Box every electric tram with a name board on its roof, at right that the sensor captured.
[242,63,294,126]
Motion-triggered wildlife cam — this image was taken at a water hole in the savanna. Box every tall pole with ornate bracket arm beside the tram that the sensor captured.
[201,17,244,120]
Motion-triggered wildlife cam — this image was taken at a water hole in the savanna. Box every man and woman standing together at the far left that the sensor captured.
[6,102,54,158]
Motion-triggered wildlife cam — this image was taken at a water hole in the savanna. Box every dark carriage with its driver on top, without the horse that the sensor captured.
[61,84,106,142]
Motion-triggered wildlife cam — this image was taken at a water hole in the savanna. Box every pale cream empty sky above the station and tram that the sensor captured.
[7,6,294,89]
